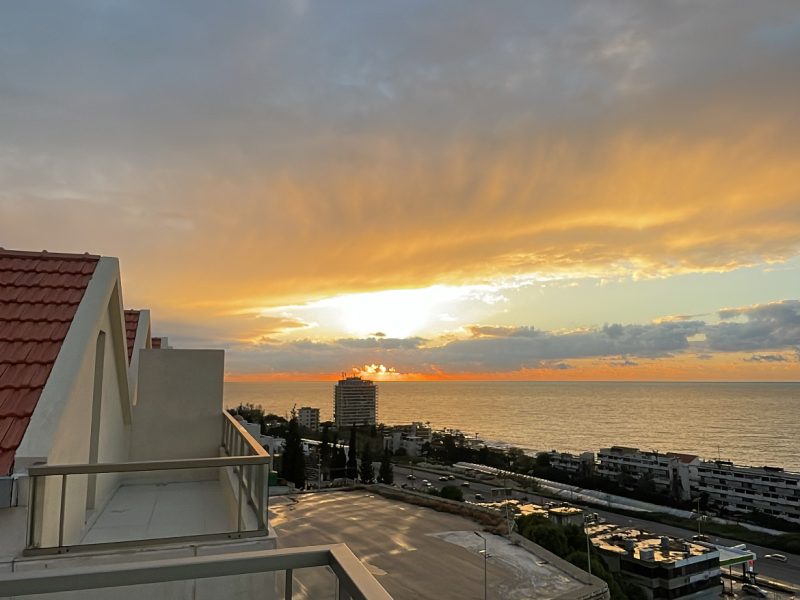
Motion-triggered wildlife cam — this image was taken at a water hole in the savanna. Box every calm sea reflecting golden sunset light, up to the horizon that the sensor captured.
[225,381,800,471]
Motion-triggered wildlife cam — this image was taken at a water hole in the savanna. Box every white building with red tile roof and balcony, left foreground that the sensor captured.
[0,250,388,600]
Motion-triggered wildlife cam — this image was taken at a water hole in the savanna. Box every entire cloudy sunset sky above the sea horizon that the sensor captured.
[0,0,800,381]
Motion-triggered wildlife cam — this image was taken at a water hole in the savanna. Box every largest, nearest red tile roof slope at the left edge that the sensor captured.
[0,248,100,475]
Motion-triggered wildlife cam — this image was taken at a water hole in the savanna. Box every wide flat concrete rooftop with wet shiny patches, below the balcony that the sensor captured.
[271,491,581,600]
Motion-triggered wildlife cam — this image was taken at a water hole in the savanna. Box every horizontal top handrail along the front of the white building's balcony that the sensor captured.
[28,455,270,477]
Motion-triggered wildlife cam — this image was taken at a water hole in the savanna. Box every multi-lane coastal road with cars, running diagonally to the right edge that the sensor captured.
[394,465,800,585]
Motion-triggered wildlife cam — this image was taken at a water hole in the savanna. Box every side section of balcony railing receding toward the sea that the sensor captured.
[222,410,272,529]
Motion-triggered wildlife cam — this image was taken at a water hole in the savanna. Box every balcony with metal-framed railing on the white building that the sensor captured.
[24,413,271,556]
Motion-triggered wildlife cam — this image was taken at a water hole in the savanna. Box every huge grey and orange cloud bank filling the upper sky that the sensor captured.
[0,1,800,310]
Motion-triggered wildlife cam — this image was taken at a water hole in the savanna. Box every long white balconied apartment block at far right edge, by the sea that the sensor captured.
[694,460,800,523]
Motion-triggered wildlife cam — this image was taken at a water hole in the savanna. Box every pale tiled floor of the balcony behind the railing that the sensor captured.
[81,480,231,544]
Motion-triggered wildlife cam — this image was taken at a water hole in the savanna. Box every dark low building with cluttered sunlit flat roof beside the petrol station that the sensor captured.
[587,524,722,600]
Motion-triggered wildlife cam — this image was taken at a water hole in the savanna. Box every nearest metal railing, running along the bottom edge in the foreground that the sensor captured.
[0,544,392,600]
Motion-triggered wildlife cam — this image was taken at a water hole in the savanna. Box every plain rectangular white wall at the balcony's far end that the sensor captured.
[131,349,225,460]
